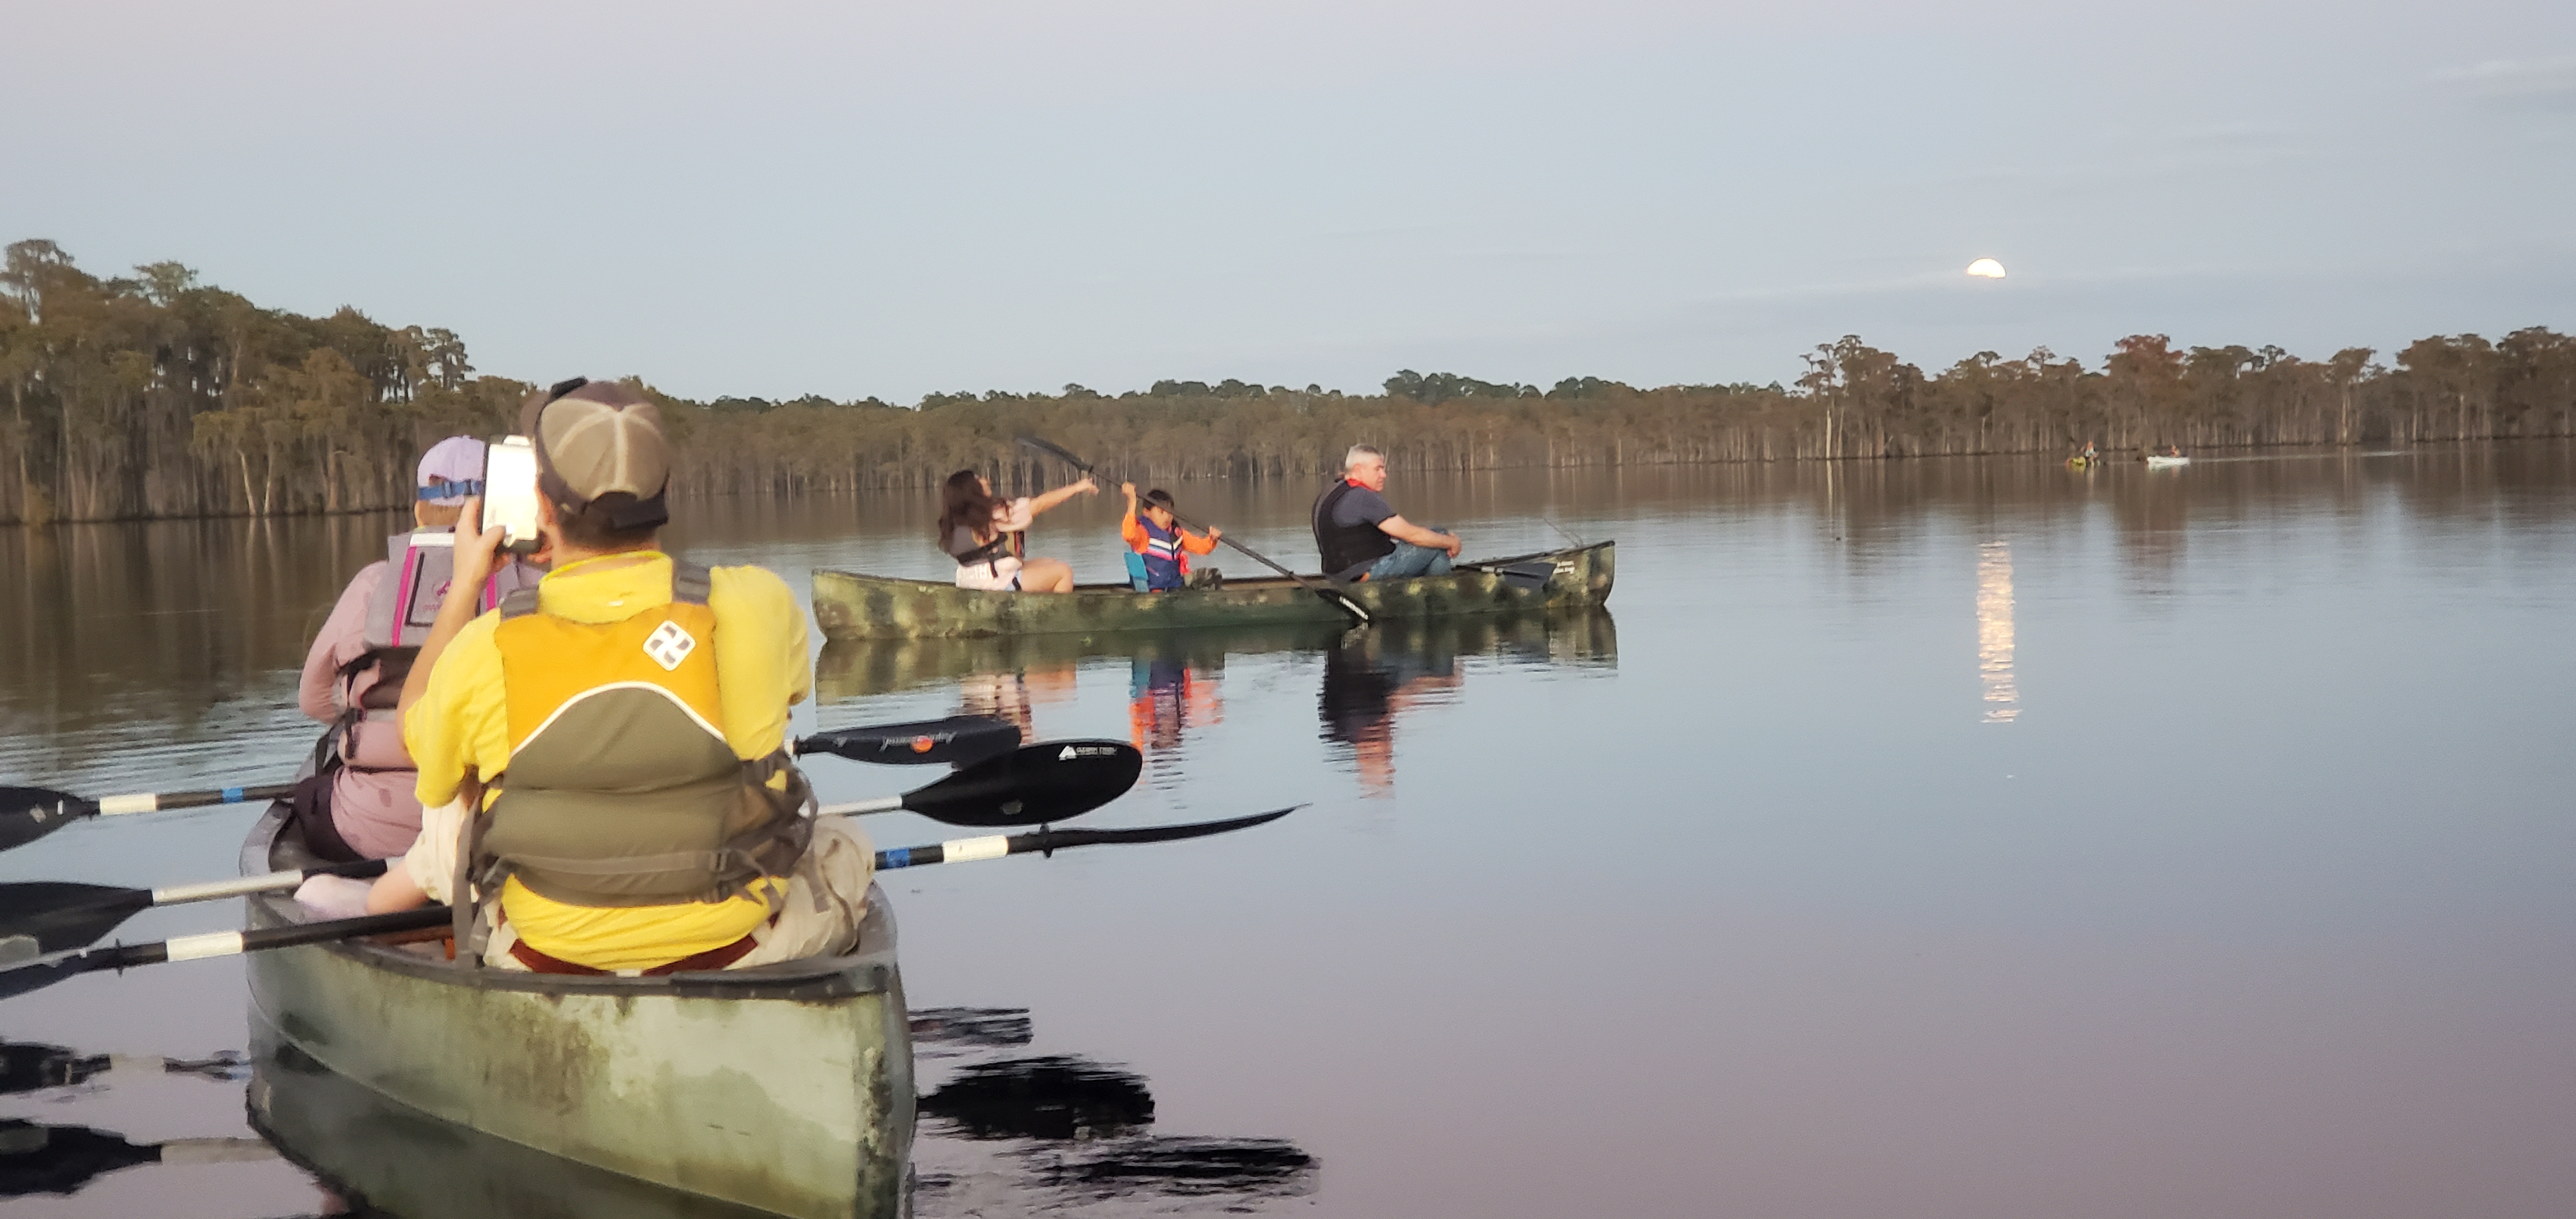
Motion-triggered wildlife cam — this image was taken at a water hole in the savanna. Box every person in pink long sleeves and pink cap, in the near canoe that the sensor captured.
[291,436,536,861]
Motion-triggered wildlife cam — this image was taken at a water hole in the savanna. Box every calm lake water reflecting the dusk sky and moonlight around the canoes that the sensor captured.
[0,446,2576,1219]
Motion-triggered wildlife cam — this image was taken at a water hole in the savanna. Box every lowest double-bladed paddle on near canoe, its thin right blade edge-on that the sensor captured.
[0,804,1301,1000]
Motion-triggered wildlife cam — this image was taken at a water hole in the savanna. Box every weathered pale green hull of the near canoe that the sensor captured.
[245,812,912,1219]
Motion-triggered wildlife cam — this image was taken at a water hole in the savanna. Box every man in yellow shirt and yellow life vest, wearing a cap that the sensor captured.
[342,379,873,974]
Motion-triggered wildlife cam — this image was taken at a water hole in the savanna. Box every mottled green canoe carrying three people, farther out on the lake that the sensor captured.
[814,541,1615,639]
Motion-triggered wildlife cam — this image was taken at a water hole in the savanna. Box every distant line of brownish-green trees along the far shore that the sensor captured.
[0,242,2576,523]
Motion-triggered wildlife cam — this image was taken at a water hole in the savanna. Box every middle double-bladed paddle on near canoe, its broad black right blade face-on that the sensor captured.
[0,742,1144,967]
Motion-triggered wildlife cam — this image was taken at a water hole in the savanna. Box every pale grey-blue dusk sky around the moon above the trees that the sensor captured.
[0,0,2576,402]
